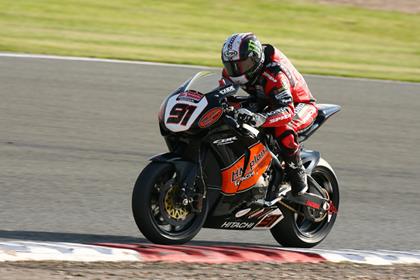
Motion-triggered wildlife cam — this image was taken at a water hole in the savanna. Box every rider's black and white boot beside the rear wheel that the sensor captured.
[283,150,308,196]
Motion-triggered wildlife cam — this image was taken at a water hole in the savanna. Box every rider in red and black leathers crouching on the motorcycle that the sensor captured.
[221,33,318,195]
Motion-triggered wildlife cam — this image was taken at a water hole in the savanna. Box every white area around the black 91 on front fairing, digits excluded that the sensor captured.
[164,94,208,132]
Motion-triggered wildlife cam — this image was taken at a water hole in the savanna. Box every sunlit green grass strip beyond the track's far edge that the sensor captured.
[0,0,420,82]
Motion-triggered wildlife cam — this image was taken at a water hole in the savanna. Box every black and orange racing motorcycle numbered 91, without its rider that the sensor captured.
[132,72,341,247]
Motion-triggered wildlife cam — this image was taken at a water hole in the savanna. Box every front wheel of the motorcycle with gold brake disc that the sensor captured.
[132,162,207,245]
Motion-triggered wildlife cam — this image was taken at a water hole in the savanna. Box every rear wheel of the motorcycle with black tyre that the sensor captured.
[271,158,339,248]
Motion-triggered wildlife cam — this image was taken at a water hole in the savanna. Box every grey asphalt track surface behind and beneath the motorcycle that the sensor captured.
[0,54,420,250]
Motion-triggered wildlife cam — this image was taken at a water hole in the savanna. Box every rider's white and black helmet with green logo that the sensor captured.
[222,33,264,85]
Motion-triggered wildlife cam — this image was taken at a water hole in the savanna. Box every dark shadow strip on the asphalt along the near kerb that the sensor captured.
[0,230,278,247]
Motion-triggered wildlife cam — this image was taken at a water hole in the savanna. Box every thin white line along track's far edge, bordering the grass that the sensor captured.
[0,52,420,85]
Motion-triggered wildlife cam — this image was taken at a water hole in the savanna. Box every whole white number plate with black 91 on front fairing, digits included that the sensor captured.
[165,91,208,132]
